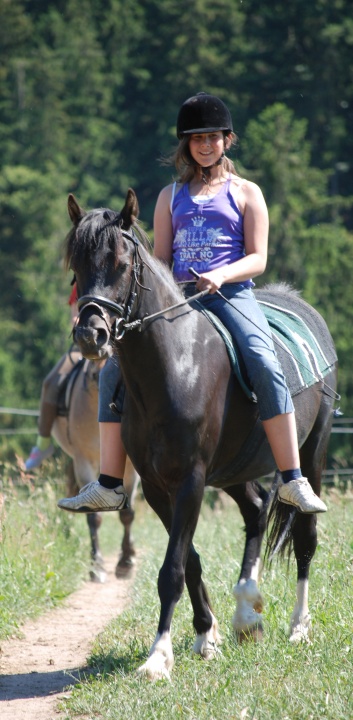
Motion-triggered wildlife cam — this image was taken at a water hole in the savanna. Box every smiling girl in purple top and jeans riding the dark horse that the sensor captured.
[59,93,326,513]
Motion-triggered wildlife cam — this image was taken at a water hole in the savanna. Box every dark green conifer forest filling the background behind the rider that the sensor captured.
[0,0,353,464]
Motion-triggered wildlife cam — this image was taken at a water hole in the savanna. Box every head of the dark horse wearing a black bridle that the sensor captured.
[65,189,144,359]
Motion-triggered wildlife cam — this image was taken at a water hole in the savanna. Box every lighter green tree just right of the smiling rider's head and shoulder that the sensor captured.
[240,103,330,286]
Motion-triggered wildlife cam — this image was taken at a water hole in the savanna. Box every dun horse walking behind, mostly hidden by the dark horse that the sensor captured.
[52,360,139,583]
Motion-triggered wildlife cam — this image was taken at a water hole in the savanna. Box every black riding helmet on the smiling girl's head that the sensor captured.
[177,92,233,140]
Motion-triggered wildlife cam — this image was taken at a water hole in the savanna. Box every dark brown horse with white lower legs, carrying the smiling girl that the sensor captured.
[66,190,336,679]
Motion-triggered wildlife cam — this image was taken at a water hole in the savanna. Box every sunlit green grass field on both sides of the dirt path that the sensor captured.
[0,467,353,720]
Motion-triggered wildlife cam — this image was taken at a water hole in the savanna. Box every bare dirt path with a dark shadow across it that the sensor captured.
[0,558,136,720]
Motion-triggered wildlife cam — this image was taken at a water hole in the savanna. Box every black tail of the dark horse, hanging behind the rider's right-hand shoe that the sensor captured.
[265,473,297,563]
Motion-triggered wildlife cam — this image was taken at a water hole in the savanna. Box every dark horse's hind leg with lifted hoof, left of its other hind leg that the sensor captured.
[224,482,268,642]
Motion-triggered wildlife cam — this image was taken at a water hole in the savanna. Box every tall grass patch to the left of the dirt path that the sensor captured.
[0,461,118,639]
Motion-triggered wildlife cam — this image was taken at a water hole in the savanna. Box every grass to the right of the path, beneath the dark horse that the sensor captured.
[58,491,353,720]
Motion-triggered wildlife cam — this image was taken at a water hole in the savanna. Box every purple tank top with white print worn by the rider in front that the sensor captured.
[172,179,254,287]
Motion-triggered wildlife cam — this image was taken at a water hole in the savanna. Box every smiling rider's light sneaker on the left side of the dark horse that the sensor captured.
[58,480,128,513]
